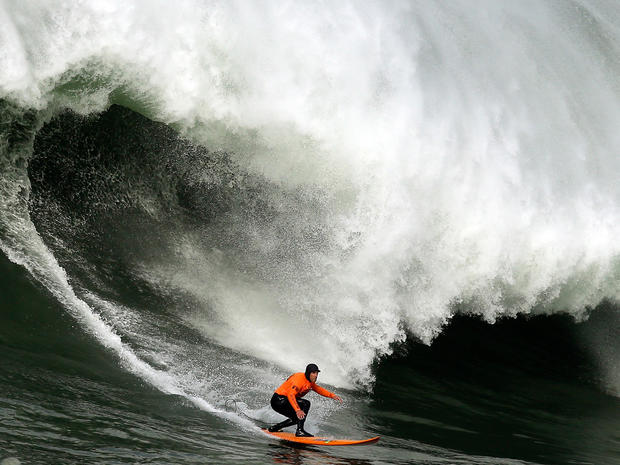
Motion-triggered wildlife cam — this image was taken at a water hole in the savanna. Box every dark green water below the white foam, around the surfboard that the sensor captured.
[0,250,620,464]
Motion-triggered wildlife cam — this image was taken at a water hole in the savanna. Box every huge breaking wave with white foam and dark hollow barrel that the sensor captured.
[0,1,620,393]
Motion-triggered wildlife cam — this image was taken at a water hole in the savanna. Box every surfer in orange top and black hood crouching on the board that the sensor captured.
[269,363,342,437]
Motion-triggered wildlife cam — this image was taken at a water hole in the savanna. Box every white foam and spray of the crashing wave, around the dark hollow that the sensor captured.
[0,0,620,392]
